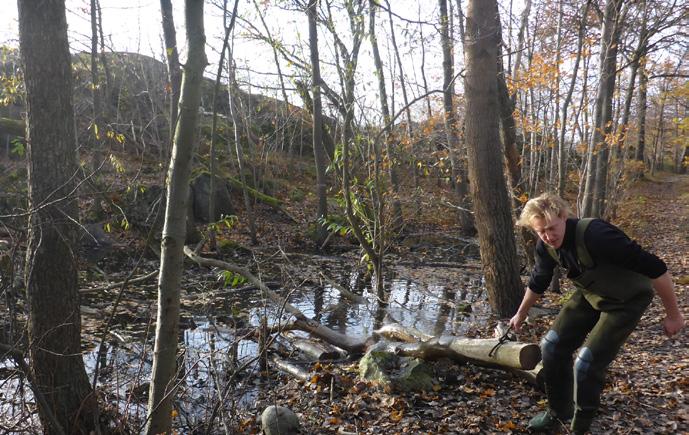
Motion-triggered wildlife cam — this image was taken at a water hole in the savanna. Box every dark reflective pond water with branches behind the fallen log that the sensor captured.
[78,254,489,430]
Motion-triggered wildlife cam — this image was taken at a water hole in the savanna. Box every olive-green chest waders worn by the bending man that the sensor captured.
[541,219,653,433]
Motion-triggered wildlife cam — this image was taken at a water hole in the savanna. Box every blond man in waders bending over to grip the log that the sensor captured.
[510,193,685,434]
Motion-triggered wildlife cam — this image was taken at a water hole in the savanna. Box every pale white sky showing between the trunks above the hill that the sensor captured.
[0,0,521,121]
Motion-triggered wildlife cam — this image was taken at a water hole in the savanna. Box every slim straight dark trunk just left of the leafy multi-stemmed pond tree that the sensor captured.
[306,0,328,246]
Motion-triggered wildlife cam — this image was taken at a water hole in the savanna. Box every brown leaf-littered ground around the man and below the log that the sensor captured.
[232,174,689,434]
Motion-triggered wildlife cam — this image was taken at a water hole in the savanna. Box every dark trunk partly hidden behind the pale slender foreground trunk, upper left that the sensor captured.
[160,0,182,164]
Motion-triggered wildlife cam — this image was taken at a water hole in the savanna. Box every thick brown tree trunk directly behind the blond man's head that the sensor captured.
[464,0,523,317]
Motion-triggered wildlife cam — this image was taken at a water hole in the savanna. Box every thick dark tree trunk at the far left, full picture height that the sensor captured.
[17,0,98,434]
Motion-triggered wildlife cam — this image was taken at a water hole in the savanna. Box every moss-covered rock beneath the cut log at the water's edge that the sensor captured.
[359,345,433,391]
